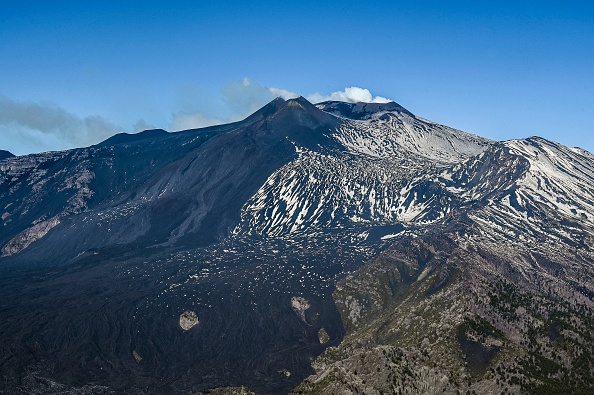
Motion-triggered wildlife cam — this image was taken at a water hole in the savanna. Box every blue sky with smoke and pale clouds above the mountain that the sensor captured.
[0,0,594,154]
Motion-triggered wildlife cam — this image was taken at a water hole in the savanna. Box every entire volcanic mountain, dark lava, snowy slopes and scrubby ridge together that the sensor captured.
[0,98,594,394]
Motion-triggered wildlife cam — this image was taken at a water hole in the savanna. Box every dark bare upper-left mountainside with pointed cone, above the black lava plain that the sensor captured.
[0,99,336,268]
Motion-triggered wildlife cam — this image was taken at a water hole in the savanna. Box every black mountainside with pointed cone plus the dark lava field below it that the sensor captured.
[0,99,350,393]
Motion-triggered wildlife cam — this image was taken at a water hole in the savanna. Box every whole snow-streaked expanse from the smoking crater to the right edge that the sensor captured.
[234,102,594,246]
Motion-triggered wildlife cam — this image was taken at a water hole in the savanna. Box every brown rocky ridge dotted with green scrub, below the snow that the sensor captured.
[295,225,594,394]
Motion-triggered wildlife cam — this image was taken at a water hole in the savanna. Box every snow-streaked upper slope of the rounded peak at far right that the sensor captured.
[426,137,594,243]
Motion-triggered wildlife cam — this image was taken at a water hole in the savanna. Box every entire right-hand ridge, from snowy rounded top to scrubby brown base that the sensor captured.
[296,138,594,394]
